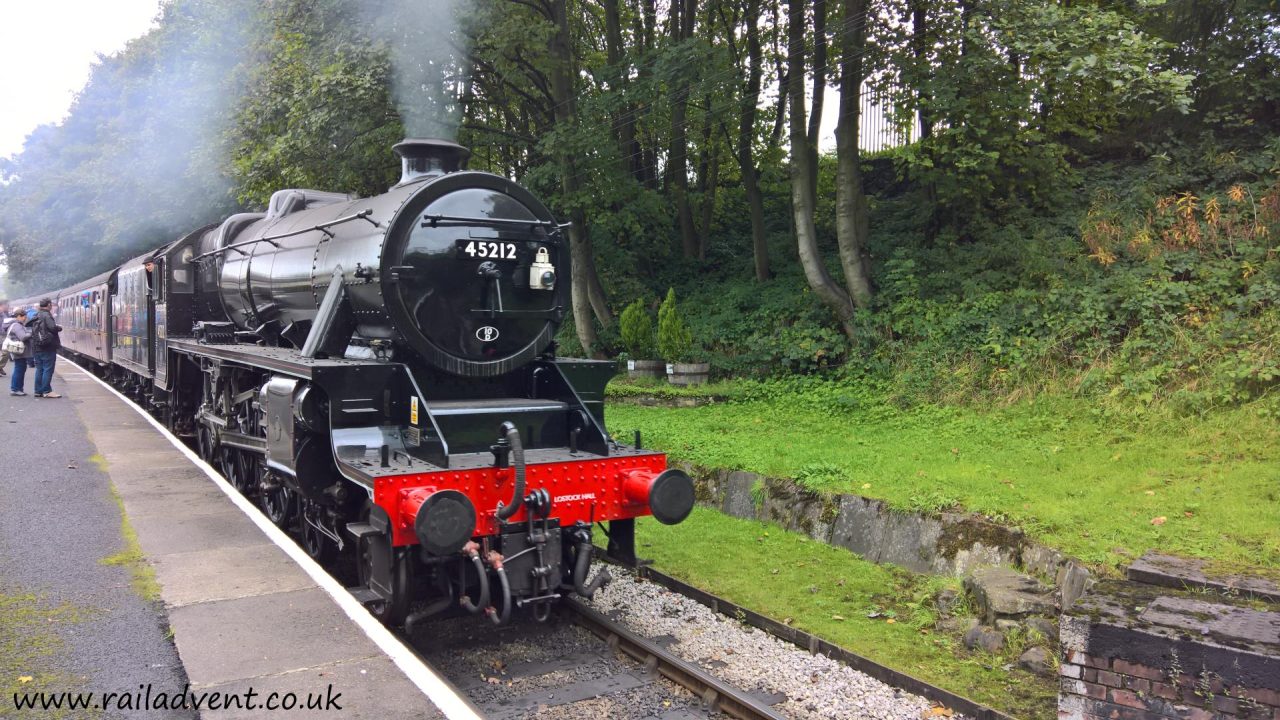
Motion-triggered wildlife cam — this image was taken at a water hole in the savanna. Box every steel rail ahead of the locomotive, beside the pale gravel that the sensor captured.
[562,598,786,720]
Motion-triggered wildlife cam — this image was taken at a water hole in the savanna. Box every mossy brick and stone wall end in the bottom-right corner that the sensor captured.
[1059,580,1280,720]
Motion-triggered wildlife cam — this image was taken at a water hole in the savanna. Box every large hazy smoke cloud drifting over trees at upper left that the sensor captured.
[0,0,259,292]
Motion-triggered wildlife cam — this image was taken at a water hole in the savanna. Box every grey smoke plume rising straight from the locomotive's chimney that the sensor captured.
[367,0,470,140]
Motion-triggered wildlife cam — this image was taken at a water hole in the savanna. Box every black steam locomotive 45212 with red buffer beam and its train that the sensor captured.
[15,138,694,626]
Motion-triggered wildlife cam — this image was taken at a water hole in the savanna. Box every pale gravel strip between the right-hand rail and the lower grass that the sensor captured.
[590,568,952,720]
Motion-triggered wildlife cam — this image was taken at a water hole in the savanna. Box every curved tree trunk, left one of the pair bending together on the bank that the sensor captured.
[787,0,855,338]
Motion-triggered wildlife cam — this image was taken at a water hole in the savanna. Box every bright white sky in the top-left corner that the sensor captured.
[0,0,160,158]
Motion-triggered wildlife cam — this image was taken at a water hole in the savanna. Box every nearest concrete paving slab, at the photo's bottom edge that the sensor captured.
[195,657,443,720]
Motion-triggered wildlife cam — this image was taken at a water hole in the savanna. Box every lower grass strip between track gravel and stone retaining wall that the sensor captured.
[624,507,1057,719]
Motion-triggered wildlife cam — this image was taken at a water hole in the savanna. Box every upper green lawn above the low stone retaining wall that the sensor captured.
[608,388,1280,574]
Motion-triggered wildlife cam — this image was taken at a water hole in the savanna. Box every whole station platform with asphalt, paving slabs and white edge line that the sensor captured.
[0,359,479,719]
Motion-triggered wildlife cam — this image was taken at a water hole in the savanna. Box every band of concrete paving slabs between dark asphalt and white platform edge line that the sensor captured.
[42,369,468,720]
